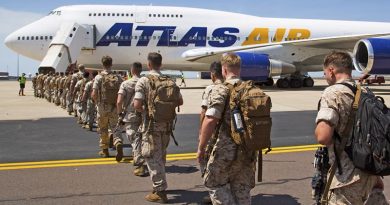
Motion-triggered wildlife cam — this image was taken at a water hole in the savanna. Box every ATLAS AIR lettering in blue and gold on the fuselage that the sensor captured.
[96,23,310,47]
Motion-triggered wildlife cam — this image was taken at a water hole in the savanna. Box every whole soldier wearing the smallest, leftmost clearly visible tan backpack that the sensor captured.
[92,56,123,158]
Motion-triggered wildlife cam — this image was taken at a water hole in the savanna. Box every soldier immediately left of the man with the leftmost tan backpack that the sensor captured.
[83,71,98,131]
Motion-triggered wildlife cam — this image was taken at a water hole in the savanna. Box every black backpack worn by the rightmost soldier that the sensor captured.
[344,84,390,176]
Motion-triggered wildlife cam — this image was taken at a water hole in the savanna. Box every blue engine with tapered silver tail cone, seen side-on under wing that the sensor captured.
[236,52,296,82]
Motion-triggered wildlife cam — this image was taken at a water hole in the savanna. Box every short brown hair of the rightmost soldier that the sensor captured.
[324,51,353,74]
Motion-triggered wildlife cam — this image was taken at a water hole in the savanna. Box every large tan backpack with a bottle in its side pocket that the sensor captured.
[225,81,272,151]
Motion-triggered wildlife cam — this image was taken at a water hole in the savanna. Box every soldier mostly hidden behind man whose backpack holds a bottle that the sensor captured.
[199,62,223,204]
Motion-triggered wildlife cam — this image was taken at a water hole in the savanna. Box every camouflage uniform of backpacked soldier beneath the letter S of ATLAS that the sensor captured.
[134,70,183,192]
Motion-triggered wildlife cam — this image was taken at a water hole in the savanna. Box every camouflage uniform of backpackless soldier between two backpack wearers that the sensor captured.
[114,77,145,166]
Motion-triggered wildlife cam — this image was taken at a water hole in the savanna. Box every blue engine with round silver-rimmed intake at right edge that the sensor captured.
[353,38,390,74]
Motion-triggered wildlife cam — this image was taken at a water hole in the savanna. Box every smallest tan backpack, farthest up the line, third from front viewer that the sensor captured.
[101,73,122,105]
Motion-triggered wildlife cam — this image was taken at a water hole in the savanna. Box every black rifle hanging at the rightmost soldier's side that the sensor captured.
[311,147,330,205]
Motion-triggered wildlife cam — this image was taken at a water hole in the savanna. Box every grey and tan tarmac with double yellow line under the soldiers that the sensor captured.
[0,79,390,205]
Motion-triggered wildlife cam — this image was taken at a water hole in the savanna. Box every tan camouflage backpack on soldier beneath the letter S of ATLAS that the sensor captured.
[147,75,180,122]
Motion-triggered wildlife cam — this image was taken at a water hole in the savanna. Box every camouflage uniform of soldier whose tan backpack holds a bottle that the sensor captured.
[204,78,256,204]
